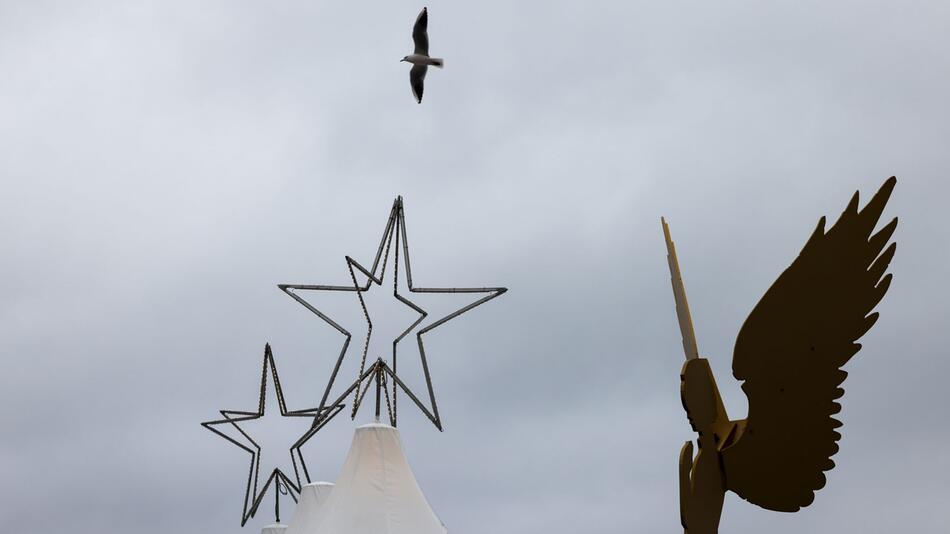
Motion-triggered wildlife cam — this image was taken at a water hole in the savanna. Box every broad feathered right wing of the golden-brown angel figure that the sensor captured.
[721,177,897,512]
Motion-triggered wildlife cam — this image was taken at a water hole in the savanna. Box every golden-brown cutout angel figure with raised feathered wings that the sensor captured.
[663,177,897,534]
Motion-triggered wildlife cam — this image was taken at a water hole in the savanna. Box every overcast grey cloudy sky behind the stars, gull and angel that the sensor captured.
[0,0,950,534]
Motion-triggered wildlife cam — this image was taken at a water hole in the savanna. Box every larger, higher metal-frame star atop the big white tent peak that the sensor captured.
[278,197,507,437]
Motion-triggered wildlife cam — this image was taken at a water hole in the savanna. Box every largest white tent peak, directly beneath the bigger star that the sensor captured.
[308,423,448,534]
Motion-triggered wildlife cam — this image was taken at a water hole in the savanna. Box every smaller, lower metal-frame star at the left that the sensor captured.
[201,344,343,527]
